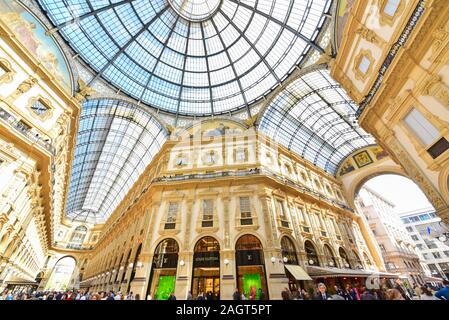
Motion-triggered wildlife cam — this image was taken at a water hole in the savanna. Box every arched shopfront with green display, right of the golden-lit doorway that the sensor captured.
[235,234,268,300]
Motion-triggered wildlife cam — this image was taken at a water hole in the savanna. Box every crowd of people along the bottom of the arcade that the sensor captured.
[0,280,449,300]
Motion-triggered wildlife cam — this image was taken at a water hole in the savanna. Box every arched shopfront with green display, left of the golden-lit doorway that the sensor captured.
[147,238,179,300]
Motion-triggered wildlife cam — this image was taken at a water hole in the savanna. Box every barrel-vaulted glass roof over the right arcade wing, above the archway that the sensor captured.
[259,69,375,175]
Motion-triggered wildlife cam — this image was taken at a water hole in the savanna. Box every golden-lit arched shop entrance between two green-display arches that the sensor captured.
[192,237,220,300]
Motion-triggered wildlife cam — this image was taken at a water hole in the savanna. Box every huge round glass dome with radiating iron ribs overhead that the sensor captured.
[38,0,331,115]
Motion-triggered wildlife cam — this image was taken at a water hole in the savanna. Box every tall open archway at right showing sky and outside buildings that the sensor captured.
[354,174,434,288]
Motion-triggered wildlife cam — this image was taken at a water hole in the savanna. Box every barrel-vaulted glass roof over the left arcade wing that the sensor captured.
[66,99,168,223]
